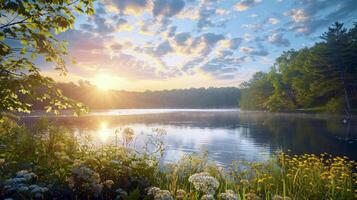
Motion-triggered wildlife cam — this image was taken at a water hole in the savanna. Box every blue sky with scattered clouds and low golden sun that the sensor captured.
[42,0,357,91]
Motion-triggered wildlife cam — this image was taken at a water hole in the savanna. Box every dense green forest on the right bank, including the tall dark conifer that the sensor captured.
[240,22,357,114]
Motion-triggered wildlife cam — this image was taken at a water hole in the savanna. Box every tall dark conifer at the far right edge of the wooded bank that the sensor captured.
[315,22,357,114]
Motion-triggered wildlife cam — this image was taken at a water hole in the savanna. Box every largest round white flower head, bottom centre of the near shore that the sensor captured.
[188,172,219,194]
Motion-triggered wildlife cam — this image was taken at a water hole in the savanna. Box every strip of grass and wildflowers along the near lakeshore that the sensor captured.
[0,118,357,200]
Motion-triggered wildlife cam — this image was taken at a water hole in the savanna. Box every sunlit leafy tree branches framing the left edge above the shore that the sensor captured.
[0,0,94,113]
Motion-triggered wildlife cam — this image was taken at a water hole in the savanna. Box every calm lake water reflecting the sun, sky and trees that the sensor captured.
[23,109,357,165]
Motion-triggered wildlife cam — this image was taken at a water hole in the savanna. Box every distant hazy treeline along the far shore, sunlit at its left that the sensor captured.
[44,84,240,109]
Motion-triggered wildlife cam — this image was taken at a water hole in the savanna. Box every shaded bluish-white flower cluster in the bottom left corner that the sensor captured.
[4,170,48,199]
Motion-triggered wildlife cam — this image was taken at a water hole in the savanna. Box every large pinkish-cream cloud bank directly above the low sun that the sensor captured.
[58,30,165,79]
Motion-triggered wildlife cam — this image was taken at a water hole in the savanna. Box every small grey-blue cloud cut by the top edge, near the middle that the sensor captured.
[153,0,185,17]
